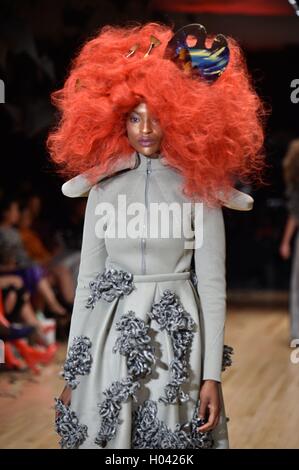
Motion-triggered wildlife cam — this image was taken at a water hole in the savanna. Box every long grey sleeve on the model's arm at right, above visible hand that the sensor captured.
[193,204,226,382]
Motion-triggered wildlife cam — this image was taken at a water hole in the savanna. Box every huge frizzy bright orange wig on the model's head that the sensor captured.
[47,23,265,200]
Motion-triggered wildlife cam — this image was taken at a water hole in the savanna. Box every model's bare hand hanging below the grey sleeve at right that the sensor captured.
[197,380,221,432]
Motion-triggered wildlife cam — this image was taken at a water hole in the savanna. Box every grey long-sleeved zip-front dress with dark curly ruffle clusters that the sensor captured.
[56,154,228,449]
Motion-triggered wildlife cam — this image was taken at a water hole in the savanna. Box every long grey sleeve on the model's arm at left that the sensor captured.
[68,186,107,348]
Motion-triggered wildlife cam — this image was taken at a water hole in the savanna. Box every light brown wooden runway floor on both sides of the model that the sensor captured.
[0,307,299,449]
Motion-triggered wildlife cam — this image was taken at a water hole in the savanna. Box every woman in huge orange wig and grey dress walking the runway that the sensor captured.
[48,23,263,449]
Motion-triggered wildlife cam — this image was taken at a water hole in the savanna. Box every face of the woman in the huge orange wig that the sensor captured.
[126,103,163,157]
